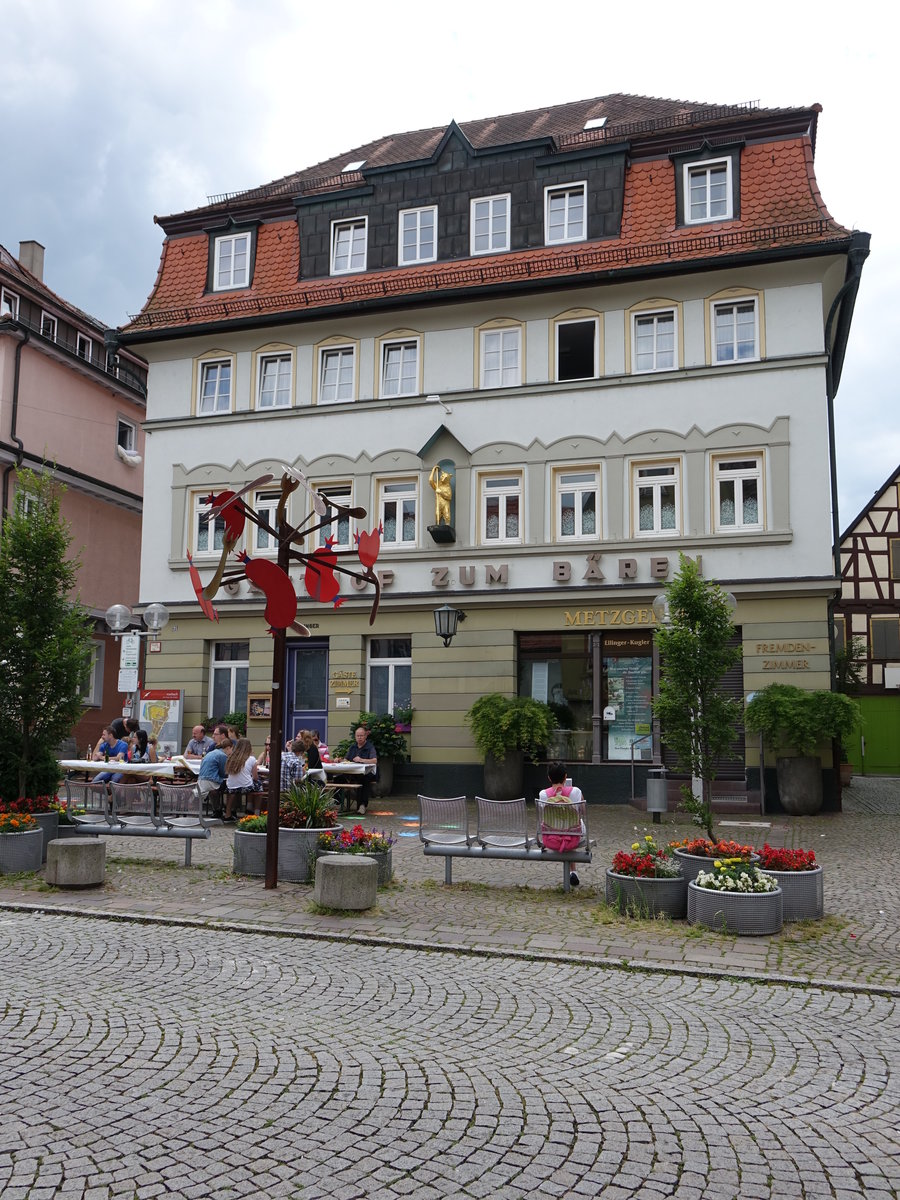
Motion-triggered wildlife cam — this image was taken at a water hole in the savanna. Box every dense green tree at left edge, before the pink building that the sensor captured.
[0,470,92,799]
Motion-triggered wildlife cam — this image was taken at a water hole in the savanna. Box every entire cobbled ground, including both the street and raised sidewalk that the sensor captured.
[0,781,900,1200]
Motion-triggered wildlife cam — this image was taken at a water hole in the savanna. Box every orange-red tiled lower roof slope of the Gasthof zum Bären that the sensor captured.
[126,135,848,334]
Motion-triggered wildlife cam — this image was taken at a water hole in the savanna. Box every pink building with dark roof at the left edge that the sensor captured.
[0,241,146,748]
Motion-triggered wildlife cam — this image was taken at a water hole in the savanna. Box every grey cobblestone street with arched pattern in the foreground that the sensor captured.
[0,907,900,1200]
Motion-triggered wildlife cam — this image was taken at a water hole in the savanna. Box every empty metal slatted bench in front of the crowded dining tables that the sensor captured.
[65,779,211,866]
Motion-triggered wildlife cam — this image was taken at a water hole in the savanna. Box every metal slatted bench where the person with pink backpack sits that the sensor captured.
[419,796,593,892]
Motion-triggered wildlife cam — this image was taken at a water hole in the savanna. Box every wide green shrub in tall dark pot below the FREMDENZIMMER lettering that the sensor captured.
[744,683,859,816]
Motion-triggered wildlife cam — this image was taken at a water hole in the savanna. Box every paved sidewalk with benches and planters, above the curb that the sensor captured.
[0,779,900,995]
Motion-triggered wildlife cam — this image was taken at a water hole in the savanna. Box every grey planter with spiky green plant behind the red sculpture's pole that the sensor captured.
[233,779,337,883]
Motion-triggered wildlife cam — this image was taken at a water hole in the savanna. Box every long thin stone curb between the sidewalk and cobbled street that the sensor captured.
[0,901,900,1000]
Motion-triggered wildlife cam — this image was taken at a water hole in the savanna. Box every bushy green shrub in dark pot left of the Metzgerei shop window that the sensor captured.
[466,691,557,800]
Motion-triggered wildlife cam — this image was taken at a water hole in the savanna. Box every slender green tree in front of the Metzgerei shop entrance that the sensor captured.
[653,554,742,839]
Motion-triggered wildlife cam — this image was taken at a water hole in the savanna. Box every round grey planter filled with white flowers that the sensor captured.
[688,858,784,935]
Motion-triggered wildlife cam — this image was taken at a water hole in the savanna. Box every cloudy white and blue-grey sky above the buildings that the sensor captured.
[0,0,900,528]
